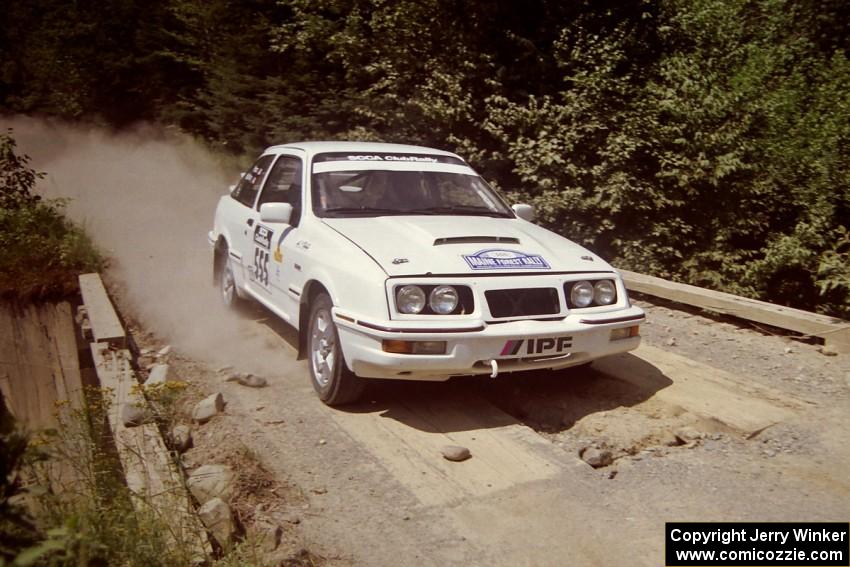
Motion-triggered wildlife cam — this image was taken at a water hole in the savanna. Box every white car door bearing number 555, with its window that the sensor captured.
[253,154,304,320]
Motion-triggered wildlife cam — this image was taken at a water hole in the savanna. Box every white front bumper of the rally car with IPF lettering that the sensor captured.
[334,306,645,381]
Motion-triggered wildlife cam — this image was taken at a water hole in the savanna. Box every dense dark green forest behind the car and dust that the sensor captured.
[0,0,850,317]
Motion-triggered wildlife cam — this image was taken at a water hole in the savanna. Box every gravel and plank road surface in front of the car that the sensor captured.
[127,303,850,565]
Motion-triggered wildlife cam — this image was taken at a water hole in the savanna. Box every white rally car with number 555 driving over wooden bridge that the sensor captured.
[209,142,644,405]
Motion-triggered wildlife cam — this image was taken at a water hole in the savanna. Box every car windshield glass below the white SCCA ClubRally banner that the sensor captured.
[313,169,514,218]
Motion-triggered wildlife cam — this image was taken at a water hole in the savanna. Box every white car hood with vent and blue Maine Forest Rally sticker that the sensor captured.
[323,216,612,276]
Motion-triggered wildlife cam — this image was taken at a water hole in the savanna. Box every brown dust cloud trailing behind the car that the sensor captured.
[0,118,295,375]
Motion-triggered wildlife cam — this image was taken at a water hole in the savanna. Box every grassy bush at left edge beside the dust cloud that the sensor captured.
[0,131,102,299]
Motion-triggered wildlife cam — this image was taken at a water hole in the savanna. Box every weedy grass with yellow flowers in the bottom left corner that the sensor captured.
[0,390,203,567]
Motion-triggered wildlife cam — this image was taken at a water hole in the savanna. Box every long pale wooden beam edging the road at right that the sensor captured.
[618,270,850,354]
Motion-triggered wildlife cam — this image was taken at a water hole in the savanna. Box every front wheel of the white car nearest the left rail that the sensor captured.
[306,293,366,406]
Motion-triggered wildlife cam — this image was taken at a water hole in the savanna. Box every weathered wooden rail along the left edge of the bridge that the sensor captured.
[80,274,212,561]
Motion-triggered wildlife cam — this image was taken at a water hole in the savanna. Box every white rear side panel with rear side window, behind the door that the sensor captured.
[225,155,275,296]
